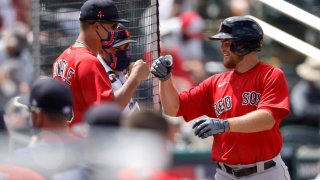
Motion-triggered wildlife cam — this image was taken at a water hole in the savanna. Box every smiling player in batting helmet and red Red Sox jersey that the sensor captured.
[151,16,290,180]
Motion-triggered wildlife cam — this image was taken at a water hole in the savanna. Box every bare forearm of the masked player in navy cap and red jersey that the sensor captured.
[114,77,141,108]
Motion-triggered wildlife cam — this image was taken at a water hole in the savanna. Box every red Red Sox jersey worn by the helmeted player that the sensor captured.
[177,62,290,165]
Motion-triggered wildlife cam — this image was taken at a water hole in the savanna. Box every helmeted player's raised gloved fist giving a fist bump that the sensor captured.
[151,55,173,81]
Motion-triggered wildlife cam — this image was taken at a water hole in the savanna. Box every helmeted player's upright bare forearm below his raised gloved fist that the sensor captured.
[160,78,180,116]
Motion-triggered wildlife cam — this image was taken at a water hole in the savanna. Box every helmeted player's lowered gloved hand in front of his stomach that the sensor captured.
[192,118,229,139]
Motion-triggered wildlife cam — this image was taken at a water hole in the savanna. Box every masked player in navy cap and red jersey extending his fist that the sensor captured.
[52,0,148,125]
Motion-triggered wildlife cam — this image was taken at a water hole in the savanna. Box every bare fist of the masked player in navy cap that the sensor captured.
[129,59,150,81]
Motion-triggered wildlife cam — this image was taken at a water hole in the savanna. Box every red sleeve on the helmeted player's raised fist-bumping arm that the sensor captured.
[177,78,214,121]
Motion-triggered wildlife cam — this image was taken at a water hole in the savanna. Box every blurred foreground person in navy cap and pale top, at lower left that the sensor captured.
[9,79,82,178]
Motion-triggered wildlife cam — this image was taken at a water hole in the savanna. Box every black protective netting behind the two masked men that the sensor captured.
[33,0,160,107]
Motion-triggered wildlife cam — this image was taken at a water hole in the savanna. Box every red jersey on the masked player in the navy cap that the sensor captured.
[52,46,113,126]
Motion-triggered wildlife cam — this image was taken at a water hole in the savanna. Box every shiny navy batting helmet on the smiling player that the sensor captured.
[209,16,263,56]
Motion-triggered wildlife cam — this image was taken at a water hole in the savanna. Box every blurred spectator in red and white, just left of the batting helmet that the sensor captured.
[160,11,207,83]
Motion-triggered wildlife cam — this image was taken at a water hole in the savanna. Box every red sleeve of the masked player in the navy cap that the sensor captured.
[77,58,113,105]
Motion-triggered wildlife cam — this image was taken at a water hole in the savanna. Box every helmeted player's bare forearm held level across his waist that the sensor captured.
[228,110,275,133]
